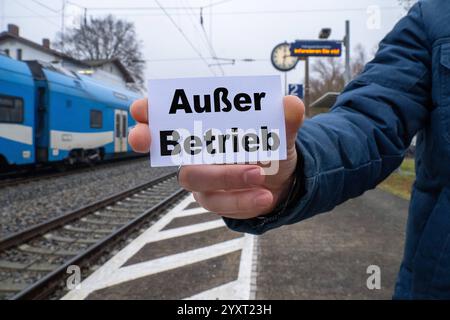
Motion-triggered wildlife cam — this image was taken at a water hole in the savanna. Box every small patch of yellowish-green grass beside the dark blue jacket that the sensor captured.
[378,159,416,200]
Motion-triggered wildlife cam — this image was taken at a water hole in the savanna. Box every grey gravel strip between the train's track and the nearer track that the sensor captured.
[0,158,174,238]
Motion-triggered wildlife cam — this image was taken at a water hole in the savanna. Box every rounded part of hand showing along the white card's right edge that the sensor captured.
[284,96,305,150]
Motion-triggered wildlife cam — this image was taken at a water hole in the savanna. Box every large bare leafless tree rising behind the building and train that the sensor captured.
[55,15,145,86]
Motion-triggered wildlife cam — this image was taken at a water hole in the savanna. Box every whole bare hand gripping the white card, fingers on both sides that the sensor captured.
[129,96,305,219]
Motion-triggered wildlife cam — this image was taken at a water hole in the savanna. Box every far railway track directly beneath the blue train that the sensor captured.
[0,157,143,189]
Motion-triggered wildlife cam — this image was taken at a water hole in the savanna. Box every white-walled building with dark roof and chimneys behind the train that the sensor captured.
[0,24,135,87]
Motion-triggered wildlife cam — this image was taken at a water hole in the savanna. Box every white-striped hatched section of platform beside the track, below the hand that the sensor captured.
[64,195,256,300]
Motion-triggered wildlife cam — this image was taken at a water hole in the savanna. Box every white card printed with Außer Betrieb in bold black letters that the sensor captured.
[148,76,287,167]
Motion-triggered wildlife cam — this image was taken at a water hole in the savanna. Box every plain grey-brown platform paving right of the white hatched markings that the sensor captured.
[256,189,409,299]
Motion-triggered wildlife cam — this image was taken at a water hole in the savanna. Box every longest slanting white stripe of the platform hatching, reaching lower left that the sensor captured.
[63,238,244,300]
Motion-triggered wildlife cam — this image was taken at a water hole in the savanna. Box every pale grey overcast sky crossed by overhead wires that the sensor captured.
[0,0,404,83]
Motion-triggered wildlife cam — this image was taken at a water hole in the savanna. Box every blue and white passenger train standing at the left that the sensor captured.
[0,55,139,169]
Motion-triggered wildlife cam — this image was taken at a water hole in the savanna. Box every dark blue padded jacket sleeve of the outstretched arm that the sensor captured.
[225,2,431,234]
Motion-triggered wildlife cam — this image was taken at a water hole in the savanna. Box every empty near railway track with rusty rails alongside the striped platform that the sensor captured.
[0,173,185,300]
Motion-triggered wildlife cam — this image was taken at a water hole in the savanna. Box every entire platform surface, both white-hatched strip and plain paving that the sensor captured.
[64,190,408,300]
